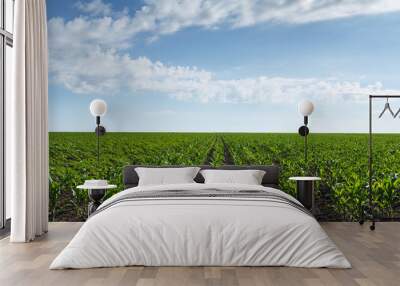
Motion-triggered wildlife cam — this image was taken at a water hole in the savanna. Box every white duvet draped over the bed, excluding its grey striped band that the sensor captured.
[50,184,351,269]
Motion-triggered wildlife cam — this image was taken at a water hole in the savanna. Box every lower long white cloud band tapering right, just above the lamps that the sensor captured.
[50,31,391,103]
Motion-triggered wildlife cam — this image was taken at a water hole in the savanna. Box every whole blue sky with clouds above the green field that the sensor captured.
[47,0,400,132]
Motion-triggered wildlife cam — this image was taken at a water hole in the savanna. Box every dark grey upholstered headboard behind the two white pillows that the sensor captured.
[123,165,279,189]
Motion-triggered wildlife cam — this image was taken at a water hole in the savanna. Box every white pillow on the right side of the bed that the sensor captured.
[200,170,265,185]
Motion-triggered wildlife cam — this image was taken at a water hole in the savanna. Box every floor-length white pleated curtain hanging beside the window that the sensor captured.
[6,0,48,242]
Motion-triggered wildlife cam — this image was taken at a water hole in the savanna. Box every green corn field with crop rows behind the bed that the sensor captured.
[49,132,400,221]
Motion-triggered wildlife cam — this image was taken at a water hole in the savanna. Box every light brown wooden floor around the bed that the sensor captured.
[0,222,400,286]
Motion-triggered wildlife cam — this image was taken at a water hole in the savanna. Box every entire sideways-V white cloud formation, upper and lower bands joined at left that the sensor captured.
[49,0,400,103]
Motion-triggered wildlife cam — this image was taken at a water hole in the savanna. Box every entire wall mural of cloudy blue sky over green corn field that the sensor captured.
[47,0,400,221]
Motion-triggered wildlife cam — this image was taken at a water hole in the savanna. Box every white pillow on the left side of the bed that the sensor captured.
[135,167,200,186]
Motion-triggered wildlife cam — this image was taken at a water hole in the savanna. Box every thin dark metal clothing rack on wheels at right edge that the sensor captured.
[360,95,400,230]
